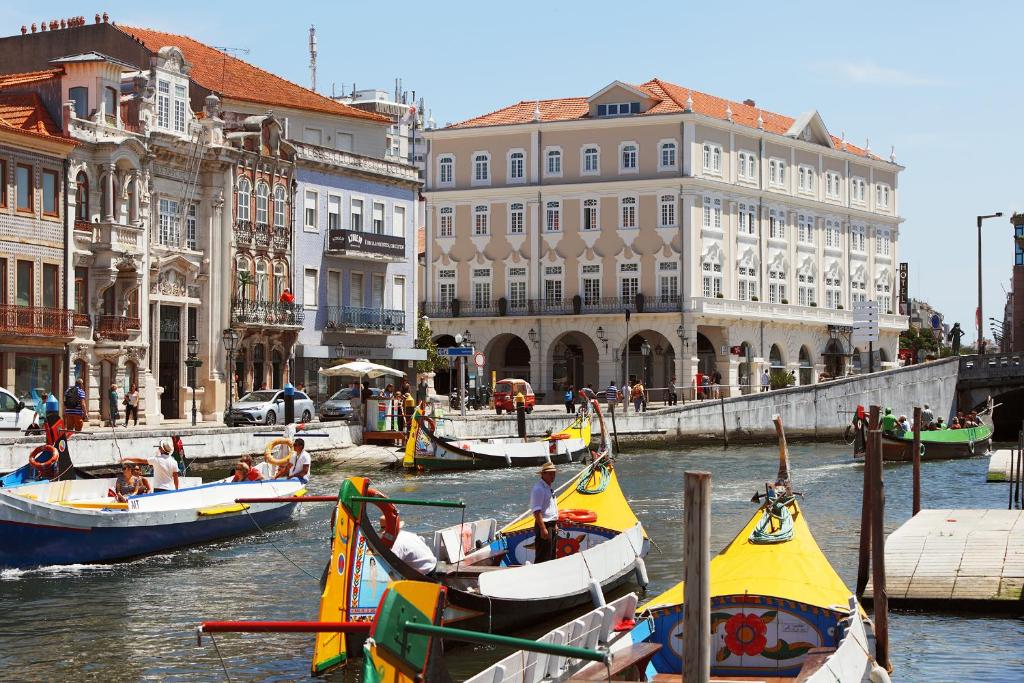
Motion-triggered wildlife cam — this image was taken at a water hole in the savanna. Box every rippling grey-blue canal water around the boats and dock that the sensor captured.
[0,443,1024,683]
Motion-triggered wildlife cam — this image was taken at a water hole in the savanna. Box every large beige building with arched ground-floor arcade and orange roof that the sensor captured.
[423,79,906,401]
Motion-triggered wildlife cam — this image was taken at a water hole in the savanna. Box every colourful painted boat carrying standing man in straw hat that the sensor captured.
[312,457,649,674]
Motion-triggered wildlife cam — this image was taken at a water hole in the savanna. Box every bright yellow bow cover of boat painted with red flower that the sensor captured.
[639,502,852,611]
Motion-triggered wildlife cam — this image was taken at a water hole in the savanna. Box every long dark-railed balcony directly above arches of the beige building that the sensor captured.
[422,294,682,318]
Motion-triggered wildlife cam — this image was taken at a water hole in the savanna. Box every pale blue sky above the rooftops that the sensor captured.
[0,0,1024,342]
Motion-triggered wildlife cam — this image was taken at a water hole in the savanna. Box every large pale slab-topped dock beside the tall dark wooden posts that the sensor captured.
[864,510,1024,613]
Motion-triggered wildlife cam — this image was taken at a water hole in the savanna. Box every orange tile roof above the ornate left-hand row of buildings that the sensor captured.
[117,25,391,124]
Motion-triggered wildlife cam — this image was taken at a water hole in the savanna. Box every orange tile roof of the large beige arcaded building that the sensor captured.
[449,78,878,159]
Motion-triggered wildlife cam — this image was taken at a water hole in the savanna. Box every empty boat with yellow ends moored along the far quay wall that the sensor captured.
[402,410,591,470]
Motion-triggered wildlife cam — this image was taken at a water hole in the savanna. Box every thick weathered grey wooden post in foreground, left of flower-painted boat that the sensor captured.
[683,472,711,683]
